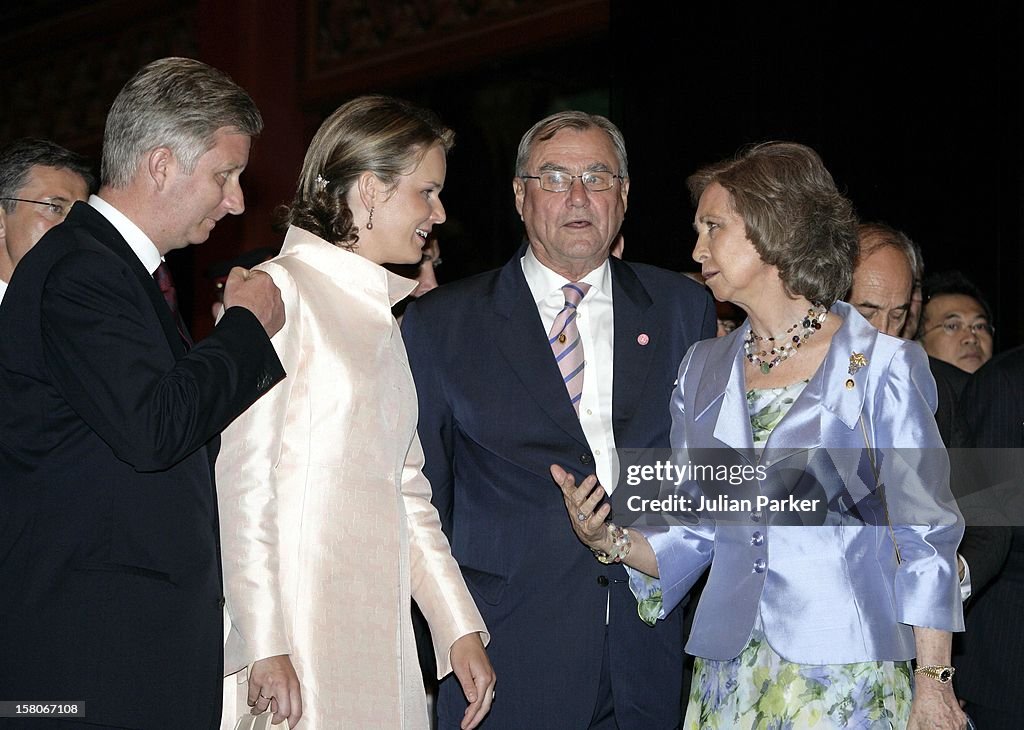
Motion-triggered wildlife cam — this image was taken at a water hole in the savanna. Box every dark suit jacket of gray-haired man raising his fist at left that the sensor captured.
[0,203,284,730]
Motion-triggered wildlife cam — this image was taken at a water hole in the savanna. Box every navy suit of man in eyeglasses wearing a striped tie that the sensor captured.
[402,249,715,730]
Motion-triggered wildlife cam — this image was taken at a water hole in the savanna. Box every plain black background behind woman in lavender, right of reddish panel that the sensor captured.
[612,3,1024,347]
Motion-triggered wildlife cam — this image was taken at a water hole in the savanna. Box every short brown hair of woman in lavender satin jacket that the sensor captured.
[686,142,858,306]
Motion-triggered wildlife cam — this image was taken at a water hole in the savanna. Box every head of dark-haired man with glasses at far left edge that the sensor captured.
[0,138,96,302]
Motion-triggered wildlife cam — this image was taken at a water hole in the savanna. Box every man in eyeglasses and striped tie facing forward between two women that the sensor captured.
[402,112,716,730]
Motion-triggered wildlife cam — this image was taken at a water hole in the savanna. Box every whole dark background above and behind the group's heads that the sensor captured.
[0,0,1024,348]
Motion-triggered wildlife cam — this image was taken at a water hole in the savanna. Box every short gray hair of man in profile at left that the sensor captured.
[99,57,263,187]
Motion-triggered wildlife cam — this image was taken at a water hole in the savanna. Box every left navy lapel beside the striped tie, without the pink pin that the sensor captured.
[492,248,589,447]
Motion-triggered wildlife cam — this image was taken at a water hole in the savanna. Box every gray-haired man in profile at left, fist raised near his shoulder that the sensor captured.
[0,58,285,730]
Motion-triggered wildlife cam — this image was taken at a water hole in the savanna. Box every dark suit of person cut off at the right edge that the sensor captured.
[953,347,1024,730]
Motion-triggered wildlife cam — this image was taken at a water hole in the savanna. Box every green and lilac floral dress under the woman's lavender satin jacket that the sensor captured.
[679,381,911,730]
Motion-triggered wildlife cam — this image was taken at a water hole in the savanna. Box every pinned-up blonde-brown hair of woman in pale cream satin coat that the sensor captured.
[283,94,455,251]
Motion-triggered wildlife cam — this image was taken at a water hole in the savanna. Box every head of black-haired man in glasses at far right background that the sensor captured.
[918,271,995,373]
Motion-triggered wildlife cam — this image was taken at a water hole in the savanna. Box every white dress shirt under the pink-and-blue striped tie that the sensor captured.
[522,247,616,493]
